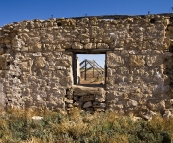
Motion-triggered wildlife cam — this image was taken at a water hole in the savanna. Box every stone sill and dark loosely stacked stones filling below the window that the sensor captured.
[66,85,106,111]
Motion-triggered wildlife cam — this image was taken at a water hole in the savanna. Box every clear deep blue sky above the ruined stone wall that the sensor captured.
[0,0,173,64]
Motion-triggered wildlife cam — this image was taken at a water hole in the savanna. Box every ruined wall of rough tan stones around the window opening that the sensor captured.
[0,15,173,118]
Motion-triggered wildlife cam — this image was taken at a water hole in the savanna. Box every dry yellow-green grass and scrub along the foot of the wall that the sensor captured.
[0,108,173,143]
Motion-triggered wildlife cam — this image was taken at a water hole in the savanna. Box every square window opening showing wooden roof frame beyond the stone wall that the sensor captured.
[74,54,106,87]
